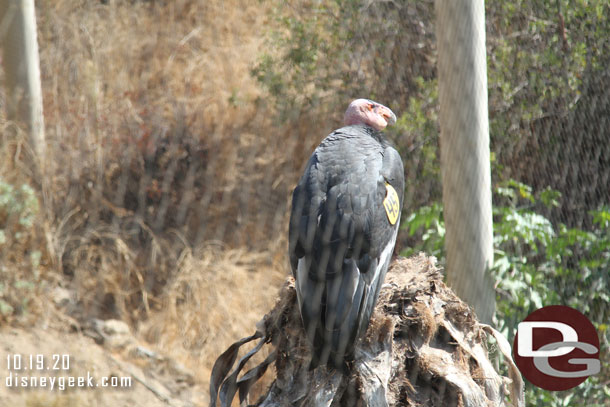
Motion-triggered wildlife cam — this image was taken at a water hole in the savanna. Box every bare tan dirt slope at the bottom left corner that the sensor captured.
[0,320,207,407]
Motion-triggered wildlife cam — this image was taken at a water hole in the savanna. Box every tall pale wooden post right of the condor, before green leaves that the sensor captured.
[435,0,495,322]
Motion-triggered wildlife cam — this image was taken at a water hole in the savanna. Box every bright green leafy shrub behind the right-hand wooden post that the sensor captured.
[402,180,610,407]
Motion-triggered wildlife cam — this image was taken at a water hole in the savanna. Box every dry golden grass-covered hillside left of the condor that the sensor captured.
[0,0,298,406]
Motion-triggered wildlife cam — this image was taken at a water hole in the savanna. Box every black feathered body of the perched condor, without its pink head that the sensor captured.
[289,125,404,369]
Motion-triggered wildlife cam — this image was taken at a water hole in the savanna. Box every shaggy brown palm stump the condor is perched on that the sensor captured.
[210,254,524,407]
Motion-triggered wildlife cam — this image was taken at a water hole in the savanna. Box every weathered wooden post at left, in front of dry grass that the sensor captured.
[0,0,45,158]
